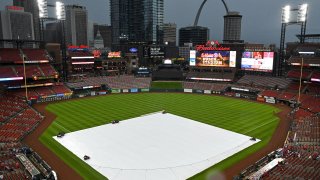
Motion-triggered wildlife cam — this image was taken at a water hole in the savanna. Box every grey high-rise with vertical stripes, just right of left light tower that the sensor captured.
[65,5,88,45]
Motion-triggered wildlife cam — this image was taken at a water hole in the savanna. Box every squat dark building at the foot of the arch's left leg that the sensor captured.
[179,26,209,46]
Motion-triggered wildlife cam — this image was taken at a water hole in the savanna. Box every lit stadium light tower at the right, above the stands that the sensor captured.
[278,4,308,76]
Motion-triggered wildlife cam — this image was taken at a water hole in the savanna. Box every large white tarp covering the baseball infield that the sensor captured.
[54,112,260,180]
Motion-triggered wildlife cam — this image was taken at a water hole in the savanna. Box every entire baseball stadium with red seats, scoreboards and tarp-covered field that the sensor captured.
[0,1,320,180]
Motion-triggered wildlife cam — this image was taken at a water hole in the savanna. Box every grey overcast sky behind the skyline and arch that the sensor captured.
[0,0,320,46]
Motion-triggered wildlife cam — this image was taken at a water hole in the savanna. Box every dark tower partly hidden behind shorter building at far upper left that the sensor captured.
[13,0,41,40]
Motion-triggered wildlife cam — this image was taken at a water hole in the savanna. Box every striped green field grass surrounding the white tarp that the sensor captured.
[40,93,280,180]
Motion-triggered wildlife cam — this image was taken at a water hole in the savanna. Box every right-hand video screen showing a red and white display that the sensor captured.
[241,51,274,72]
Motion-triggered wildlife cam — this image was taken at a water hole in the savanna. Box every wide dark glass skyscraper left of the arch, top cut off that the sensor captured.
[110,0,164,45]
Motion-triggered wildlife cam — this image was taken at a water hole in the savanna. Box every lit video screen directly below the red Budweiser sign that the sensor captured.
[190,51,237,67]
